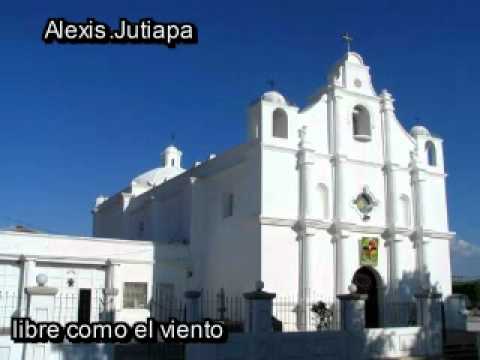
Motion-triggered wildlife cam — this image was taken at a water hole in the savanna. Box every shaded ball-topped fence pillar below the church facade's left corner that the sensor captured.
[243,281,276,334]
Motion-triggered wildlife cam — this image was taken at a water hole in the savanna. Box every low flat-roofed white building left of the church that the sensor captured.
[0,231,154,329]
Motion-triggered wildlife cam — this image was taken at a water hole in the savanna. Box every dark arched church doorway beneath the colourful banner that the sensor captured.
[353,266,379,328]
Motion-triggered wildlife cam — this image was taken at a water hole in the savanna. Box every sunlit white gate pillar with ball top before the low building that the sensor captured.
[25,274,58,359]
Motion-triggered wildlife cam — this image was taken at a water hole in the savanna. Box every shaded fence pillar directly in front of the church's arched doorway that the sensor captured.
[337,294,368,333]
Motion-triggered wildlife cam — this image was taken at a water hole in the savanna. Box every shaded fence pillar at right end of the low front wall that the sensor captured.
[415,291,442,355]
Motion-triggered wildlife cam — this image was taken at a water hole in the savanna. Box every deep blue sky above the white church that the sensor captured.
[0,0,480,275]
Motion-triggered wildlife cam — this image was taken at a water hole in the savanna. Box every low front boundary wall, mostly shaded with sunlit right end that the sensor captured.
[186,327,426,360]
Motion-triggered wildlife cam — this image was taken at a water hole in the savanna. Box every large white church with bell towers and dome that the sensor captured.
[93,51,454,330]
